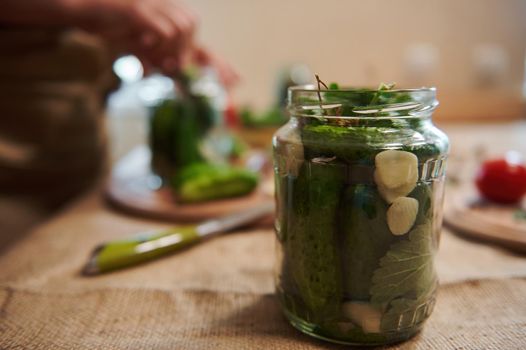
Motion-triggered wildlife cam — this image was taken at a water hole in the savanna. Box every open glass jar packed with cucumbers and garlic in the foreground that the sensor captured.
[273,86,449,345]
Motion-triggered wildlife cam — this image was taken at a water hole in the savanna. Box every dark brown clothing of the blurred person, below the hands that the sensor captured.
[0,27,116,206]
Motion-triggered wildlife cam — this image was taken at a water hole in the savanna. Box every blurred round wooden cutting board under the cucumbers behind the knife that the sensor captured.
[106,147,273,225]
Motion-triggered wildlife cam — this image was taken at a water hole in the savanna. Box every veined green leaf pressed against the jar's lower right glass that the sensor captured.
[370,220,437,307]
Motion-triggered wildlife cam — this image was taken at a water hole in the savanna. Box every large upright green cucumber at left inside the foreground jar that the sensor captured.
[285,161,345,318]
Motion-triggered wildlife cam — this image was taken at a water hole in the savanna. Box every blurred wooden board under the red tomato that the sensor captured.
[444,188,526,253]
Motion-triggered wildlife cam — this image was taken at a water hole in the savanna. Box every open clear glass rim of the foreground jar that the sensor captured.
[288,84,438,119]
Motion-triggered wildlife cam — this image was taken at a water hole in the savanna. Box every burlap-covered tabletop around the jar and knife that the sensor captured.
[0,122,526,349]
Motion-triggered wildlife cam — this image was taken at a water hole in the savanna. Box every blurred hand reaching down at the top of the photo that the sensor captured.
[71,0,197,73]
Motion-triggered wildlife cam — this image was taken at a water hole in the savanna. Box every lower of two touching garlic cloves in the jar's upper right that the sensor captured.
[387,197,418,236]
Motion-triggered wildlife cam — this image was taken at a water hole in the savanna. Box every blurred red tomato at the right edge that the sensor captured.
[476,159,526,203]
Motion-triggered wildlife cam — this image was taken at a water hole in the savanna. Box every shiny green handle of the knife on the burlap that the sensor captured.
[83,226,200,275]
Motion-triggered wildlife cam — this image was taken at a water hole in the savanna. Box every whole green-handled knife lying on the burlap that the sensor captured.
[82,202,274,276]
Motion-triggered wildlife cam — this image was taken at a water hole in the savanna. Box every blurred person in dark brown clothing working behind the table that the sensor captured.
[0,0,236,206]
